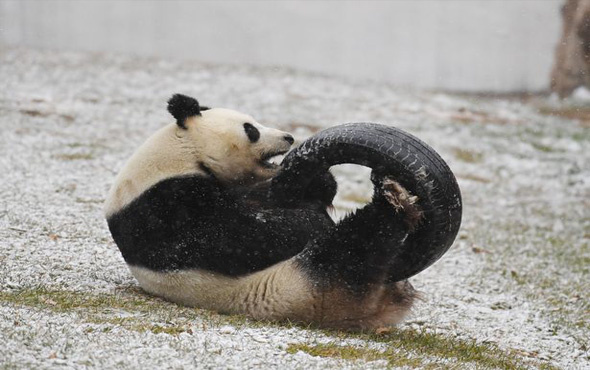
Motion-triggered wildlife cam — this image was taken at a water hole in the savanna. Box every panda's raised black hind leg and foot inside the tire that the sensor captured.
[298,178,421,294]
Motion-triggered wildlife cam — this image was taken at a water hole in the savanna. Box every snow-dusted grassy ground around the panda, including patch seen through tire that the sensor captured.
[0,49,590,369]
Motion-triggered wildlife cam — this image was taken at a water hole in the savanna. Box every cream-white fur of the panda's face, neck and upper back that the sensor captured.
[105,108,291,217]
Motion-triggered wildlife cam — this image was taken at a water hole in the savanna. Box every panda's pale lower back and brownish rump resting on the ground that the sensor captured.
[129,258,414,329]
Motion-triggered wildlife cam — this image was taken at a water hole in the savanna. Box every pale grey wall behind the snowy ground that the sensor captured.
[0,0,561,92]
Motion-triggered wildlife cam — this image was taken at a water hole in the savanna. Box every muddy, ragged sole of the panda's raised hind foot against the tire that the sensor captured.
[381,178,422,231]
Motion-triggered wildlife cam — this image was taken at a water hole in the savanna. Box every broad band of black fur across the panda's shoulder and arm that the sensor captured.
[108,171,333,276]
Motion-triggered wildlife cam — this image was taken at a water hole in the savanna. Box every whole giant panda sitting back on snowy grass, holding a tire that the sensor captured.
[105,94,421,330]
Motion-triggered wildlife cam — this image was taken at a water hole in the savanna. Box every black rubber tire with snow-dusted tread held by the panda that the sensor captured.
[270,123,462,282]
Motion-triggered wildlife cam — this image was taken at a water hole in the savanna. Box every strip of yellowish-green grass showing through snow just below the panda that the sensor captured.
[0,287,551,369]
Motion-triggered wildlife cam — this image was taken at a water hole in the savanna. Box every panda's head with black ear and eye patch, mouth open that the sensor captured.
[168,94,294,184]
